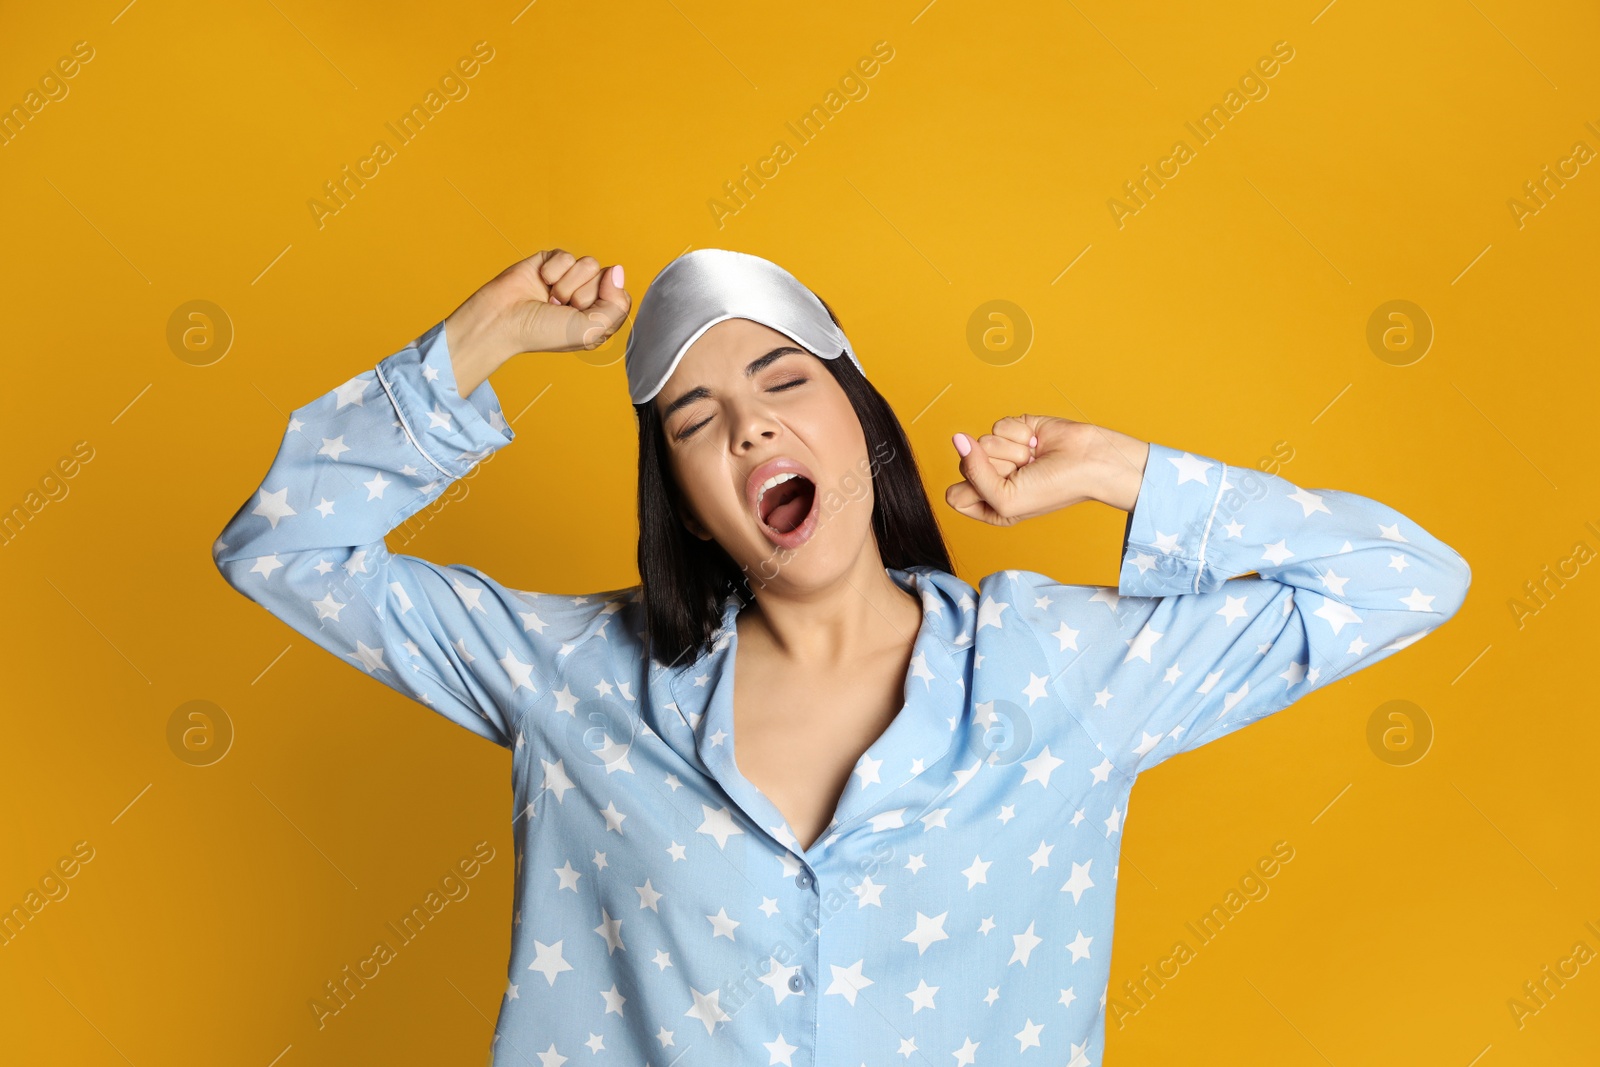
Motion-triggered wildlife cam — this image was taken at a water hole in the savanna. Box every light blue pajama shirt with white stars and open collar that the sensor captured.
[214,323,1472,1067]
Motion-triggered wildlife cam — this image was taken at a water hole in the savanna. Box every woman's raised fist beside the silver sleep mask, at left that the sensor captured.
[445,248,634,397]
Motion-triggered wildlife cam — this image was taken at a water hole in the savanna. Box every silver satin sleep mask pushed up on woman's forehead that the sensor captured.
[624,248,866,405]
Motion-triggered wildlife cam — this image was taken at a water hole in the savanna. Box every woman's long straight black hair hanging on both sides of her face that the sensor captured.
[634,294,955,665]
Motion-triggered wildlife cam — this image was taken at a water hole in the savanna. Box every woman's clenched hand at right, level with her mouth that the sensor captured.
[944,414,1149,526]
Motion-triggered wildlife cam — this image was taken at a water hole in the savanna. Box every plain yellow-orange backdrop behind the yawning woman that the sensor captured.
[0,0,1600,1067]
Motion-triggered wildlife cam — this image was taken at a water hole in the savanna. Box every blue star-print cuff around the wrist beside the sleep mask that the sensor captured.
[376,322,517,478]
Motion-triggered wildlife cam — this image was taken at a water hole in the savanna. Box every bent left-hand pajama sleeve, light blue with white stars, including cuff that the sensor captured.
[213,323,621,747]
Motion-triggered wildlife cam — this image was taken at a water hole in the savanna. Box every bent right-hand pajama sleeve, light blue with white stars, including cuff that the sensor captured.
[1022,443,1472,776]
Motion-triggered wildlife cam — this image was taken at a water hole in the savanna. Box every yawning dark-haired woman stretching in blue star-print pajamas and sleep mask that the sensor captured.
[214,250,1470,1067]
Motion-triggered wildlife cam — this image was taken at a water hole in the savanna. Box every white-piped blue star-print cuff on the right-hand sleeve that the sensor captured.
[1117,442,1227,597]
